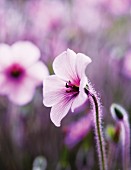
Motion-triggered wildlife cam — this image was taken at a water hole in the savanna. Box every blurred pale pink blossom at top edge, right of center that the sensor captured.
[72,0,107,33]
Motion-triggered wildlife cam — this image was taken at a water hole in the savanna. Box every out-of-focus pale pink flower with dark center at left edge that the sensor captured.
[0,41,48,105]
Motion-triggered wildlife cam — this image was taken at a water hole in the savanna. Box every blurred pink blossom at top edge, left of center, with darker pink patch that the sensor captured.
[26,0,69,36]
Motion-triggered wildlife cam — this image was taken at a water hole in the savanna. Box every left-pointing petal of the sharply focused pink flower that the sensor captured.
[43,75,66,107]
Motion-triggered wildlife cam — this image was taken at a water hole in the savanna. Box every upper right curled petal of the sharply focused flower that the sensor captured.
[76,53,91,79]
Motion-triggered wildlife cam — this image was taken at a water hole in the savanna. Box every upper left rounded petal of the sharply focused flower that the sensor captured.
[53,49,77,82]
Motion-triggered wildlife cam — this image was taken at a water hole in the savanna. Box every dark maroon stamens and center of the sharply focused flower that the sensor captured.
[65,81,79,94]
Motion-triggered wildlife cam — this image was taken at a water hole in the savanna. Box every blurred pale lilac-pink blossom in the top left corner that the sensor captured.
[0,0,27,43]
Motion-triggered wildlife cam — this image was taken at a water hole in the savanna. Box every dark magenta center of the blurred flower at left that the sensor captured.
[7,64,25,80]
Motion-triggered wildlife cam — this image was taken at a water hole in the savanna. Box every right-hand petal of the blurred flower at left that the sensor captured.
[27,61,49,85]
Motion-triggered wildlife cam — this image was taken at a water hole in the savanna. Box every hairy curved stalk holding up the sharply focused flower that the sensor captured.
[85,86,107,170]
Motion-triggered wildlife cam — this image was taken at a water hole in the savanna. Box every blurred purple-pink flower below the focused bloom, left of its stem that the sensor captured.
[65,113,93,148]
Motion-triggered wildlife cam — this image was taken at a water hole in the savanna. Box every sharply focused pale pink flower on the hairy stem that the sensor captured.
[43,49,91,126]
